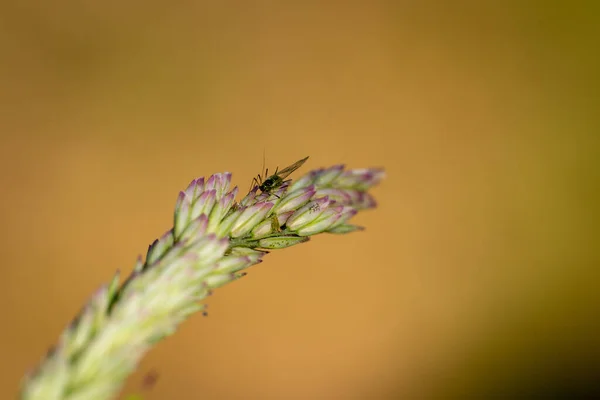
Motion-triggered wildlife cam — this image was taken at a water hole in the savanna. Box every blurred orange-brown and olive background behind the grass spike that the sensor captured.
[0,0,600,399]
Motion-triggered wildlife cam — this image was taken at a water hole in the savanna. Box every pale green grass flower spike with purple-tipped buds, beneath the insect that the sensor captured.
[21,162,384,400]
